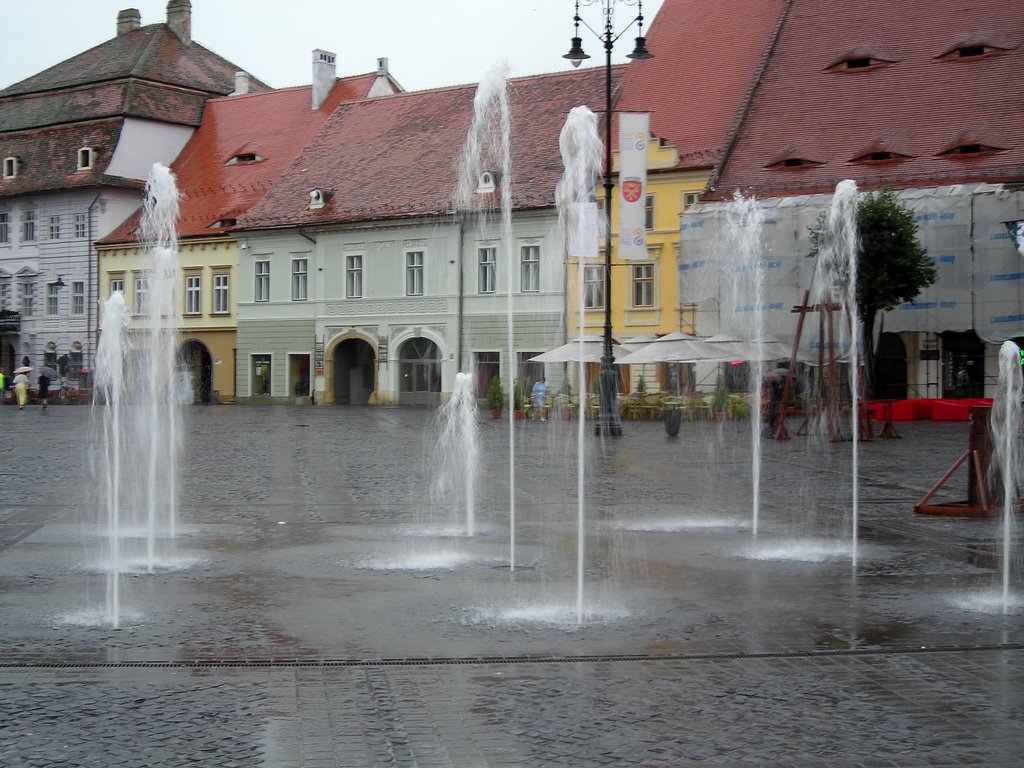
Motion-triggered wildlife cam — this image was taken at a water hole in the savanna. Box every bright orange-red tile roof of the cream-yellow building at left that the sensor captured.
[102,74,376,244]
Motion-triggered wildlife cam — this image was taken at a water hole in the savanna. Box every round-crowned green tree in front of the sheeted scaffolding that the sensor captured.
[811,187,938,394]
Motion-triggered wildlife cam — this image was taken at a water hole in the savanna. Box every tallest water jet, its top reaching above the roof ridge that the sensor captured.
[456,61,517,570]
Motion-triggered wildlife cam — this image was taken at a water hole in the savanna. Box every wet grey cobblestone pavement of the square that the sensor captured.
[0,406,1024,768]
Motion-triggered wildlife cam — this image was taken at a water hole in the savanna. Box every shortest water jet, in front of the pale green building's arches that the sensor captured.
[431,372,480,536]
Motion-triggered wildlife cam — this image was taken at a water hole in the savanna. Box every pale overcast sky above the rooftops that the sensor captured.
[0,0,663,90]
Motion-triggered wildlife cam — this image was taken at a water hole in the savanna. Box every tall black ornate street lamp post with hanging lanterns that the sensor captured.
[563,0,653,435]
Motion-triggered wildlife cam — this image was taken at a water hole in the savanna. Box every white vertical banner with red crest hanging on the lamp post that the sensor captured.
[618,112,650,261]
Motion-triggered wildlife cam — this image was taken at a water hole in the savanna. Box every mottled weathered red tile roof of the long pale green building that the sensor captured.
[242,68,622,228]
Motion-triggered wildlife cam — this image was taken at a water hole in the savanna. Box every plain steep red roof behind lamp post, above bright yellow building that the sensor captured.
[615,0,785,168]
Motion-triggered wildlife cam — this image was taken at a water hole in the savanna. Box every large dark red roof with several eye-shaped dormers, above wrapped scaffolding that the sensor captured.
[714,0,1024,197]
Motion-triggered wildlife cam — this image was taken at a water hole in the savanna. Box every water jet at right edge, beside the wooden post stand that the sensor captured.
[989,341,1022,613]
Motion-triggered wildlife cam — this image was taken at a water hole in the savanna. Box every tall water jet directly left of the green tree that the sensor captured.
[814,179,861,568]
